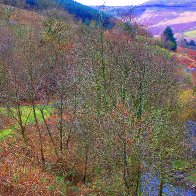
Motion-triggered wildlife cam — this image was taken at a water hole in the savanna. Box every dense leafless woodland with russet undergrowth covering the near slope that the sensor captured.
[0,2,195,196]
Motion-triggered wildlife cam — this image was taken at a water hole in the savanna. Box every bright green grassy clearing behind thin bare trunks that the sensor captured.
[0,105,54,141]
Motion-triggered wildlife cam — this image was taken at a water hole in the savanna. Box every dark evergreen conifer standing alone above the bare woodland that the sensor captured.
[161,26,177,51]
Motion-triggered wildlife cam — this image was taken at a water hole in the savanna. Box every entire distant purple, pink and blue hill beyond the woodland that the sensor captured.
[93,0,196,40]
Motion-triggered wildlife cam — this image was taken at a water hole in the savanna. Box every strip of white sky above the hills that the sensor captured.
[76,0,148,6]
